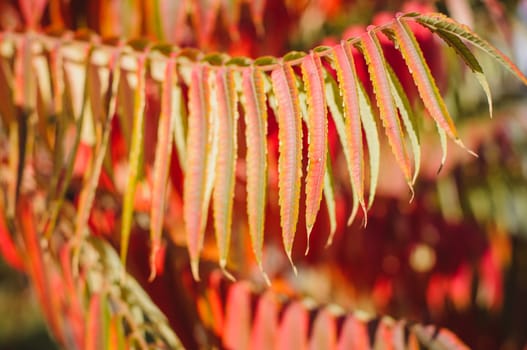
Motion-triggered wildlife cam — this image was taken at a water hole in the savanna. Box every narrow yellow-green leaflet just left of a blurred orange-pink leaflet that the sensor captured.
[121,52,147,270]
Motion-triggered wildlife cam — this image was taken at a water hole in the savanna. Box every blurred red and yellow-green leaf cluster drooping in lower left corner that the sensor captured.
[0,195,182,349]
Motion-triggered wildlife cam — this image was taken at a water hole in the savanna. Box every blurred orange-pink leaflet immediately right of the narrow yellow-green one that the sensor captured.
[149,57,178,280]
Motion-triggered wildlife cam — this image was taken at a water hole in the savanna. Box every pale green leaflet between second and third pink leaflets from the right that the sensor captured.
[359,82,381,209]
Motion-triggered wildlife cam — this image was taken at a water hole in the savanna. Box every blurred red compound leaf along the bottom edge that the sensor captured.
[191,272,466,349]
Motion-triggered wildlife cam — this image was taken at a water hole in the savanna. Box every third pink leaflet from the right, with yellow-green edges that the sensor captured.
[333,41,366,224]
